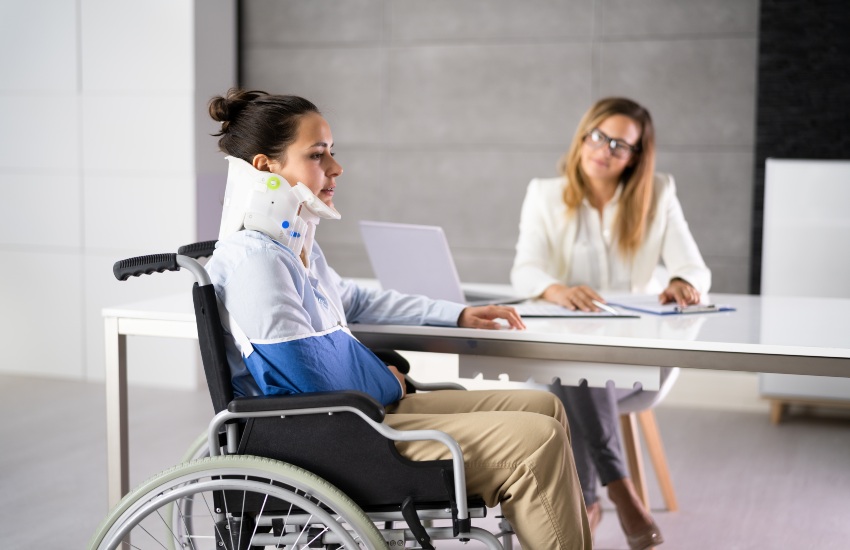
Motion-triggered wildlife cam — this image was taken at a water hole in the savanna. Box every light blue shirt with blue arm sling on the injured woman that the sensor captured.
[206,230,465,405]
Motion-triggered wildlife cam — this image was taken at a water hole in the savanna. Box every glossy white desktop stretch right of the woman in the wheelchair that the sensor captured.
[351,294,850,378]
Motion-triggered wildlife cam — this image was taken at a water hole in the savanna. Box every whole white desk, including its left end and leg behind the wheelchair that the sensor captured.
[103,292,850,506]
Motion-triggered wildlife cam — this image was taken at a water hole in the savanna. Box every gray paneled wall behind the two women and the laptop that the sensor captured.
[237,0,758,292]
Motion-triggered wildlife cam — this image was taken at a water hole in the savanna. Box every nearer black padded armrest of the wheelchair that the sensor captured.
[227,390,386,422]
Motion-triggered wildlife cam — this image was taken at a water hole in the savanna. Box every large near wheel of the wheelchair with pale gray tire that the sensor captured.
[89,455,387,550]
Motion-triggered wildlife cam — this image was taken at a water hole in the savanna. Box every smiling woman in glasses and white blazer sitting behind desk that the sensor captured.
[511,98,711,550]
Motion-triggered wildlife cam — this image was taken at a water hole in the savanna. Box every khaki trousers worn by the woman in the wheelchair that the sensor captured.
[386,390,592,550]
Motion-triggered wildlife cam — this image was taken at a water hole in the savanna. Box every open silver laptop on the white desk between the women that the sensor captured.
[360,221,522,305]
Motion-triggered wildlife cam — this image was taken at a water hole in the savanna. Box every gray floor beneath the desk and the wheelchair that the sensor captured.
[0,375,850,550]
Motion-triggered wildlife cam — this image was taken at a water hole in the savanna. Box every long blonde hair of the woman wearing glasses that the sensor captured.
[558,97,655,256]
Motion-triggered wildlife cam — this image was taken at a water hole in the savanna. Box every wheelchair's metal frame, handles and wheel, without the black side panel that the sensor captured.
[89,241,512,550]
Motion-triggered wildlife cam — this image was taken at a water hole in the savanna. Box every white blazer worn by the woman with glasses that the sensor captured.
[511,173,711,296]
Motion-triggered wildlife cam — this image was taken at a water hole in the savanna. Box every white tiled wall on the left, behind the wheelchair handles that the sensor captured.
[0,0,235,386]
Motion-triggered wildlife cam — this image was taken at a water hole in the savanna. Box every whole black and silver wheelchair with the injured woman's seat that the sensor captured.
[89,241,513,550]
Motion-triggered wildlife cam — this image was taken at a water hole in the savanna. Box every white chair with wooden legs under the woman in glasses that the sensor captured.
[617,367,679,512]
